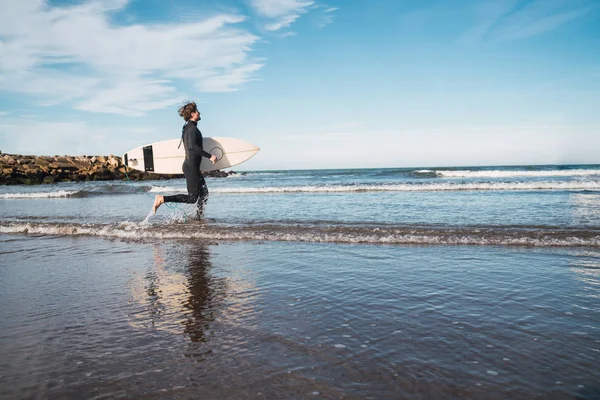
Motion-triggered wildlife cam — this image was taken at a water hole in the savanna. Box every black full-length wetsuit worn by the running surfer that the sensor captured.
[164,121,211,217]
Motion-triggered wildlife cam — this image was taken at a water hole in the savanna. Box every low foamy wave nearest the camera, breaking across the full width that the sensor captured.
[0,221,600,247]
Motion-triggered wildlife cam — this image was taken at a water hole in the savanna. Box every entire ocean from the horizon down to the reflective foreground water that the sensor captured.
[0,165,600,399]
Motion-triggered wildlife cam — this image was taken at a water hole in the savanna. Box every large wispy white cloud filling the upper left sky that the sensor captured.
[0,0,262,116]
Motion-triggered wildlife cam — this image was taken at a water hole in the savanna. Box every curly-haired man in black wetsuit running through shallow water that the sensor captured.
[152,102,217,218]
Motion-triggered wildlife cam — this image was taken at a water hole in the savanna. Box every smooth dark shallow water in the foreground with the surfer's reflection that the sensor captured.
[0,235,600,399]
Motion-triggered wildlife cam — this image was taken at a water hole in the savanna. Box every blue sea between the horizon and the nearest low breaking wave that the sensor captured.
[0,166,600,238]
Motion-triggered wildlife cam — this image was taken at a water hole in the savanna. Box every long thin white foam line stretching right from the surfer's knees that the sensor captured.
[211,181,600,193]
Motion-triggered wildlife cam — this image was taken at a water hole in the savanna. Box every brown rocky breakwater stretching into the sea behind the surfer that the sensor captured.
[0,153,229,185]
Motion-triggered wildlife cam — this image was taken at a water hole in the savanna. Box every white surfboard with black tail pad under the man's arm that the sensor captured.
[123,137,260,174]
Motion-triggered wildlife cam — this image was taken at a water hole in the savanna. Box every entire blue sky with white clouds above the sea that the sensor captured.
[0,0,600,171]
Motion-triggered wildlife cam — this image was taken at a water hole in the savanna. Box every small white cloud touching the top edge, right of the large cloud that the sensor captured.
[250,0,315,31]
